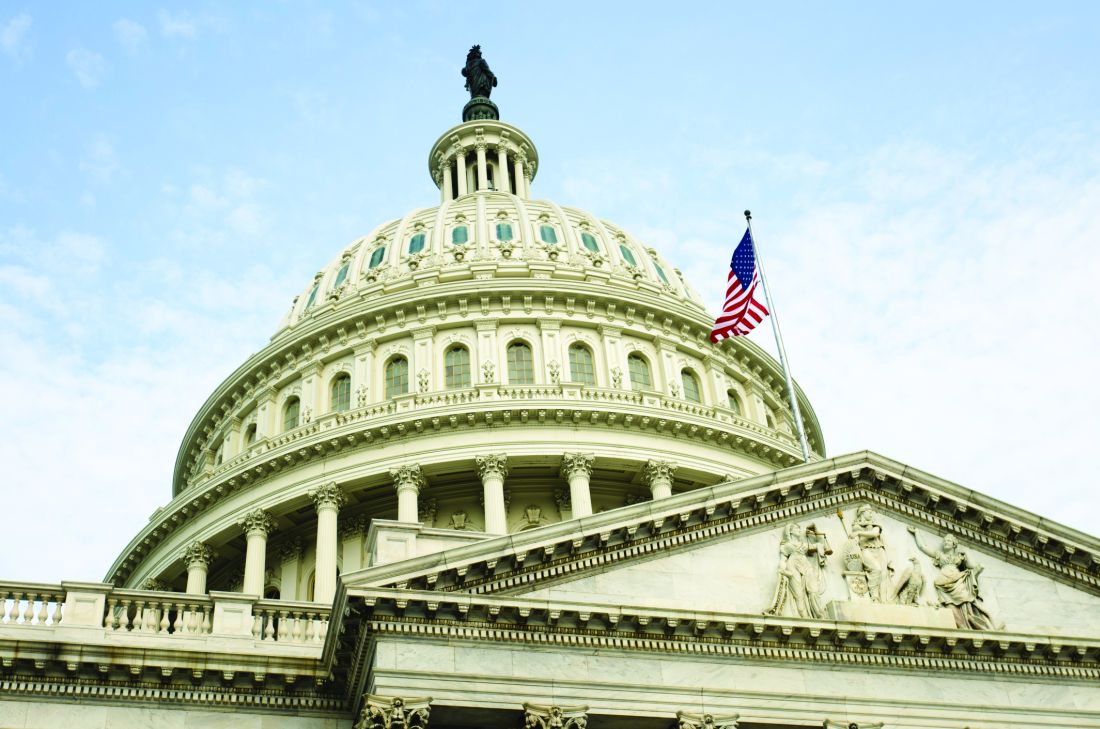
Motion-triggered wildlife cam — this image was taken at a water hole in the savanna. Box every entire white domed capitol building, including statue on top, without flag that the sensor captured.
[0,48,1100,729]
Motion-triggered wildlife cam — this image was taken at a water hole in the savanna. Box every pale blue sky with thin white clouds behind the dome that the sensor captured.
[0,1,1100,581]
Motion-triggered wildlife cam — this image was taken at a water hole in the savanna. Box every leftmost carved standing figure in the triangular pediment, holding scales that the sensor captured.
[765,522,833,618]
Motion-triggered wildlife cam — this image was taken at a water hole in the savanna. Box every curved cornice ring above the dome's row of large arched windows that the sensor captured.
[174,264,824,493]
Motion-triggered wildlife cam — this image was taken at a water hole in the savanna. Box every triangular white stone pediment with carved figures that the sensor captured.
[345,452,1100,636]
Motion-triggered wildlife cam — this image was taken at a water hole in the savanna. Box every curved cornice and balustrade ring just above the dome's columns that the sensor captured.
[106,393,801,584]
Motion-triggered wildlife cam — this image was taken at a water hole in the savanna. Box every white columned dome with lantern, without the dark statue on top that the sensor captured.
[107,89,824,601]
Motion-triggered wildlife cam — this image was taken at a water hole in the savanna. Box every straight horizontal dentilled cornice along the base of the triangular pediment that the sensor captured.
[341,588,1100,682]
